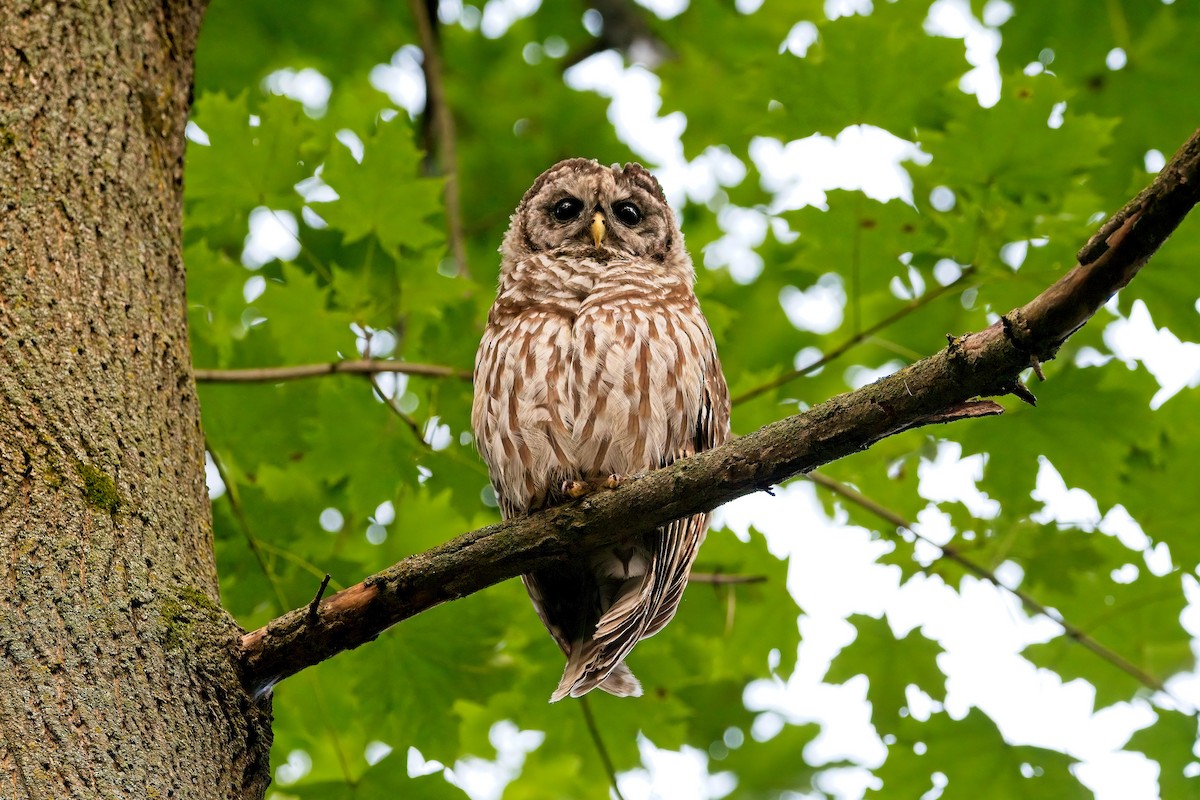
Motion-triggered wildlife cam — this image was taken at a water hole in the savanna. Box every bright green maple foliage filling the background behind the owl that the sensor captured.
[187,0,1200,800]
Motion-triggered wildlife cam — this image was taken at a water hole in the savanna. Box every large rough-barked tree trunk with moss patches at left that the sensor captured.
[0,0,270,800]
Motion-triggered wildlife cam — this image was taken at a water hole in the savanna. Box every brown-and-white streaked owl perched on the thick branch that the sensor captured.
[472,158,730,702]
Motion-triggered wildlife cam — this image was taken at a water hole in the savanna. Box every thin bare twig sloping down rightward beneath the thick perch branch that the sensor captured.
[805,471,1188,709]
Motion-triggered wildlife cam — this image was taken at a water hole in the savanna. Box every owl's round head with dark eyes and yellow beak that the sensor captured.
[500,158,691,271]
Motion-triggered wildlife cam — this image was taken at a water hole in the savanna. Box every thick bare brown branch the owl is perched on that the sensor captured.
[241,131,1200,691]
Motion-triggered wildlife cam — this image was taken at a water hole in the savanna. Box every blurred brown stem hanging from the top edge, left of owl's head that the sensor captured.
[408,0,469,276]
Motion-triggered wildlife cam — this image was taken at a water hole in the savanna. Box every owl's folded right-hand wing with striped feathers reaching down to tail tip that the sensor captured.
[551,301,730,700]
